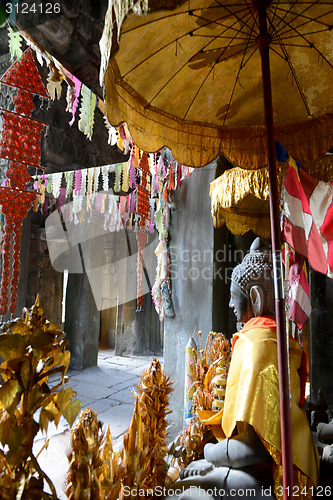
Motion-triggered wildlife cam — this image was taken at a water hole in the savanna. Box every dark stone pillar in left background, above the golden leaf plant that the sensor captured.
[64,273,100,370]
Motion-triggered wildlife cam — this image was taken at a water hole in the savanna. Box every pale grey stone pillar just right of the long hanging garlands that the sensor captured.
[164,162,216,437]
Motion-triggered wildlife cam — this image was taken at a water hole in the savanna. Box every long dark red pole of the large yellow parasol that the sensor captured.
[255,0,293,499]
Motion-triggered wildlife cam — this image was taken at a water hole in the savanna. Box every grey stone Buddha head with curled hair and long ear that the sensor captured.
[229,238,275,323]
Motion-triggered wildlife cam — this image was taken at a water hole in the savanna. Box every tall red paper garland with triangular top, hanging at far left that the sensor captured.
[0,49,49,316]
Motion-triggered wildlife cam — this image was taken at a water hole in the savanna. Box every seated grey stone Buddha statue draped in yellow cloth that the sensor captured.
[168,238,318,500]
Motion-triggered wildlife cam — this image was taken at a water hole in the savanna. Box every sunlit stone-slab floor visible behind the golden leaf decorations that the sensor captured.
[34,350,161,500]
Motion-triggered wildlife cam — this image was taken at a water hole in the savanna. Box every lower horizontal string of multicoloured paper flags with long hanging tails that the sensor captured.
[29,149,193,317]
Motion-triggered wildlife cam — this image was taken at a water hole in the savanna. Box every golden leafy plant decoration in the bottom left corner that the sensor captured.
[0,296,80,500]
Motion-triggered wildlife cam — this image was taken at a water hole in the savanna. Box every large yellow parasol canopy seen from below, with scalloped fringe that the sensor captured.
[104,0,333,169]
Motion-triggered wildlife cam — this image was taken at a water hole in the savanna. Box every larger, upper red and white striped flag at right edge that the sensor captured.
[282,157,333,278]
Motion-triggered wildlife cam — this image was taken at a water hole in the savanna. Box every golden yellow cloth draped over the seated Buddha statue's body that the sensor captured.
[198,317,319,499]
